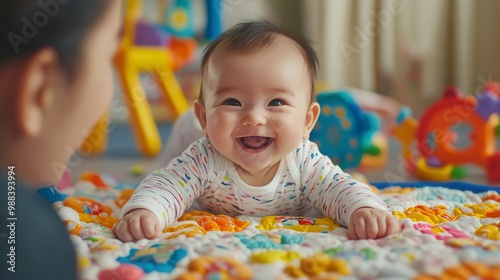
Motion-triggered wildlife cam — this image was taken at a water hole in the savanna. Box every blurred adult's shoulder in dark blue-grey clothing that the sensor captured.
[0,176,77,279]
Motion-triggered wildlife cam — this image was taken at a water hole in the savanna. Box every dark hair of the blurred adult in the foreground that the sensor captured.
[0,0,108,74]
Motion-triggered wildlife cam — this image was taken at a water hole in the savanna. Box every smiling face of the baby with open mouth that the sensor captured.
[199,38,319,173]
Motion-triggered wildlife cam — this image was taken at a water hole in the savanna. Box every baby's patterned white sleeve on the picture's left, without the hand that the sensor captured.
[121,138,219,228]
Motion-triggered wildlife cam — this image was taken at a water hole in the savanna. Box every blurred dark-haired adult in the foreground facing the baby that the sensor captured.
[0,0,121,280]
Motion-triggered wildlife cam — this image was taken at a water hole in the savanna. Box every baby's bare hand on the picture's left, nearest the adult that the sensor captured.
[113,209,162,242]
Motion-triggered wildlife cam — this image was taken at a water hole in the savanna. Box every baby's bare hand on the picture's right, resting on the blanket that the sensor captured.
[347,208,401,239]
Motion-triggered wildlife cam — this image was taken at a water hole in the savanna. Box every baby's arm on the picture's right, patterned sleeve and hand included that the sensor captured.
[301,143,400,239]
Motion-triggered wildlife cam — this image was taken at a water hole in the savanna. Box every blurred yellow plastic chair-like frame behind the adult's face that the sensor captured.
[82,0,189,156]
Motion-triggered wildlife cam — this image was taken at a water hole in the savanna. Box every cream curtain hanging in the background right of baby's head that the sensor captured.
[301,0,500,112]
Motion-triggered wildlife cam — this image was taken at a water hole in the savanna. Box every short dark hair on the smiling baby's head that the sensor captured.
[199,20,319,103]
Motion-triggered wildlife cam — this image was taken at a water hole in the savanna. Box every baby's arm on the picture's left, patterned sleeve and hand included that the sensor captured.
[113,140,214,241]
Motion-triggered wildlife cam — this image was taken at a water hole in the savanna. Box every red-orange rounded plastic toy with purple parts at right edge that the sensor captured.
[393,83,500,181]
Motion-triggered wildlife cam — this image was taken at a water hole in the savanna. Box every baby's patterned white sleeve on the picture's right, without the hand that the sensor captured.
[297,141,388,226]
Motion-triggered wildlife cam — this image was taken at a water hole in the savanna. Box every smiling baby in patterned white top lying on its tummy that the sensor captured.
[114,21,400,241]
